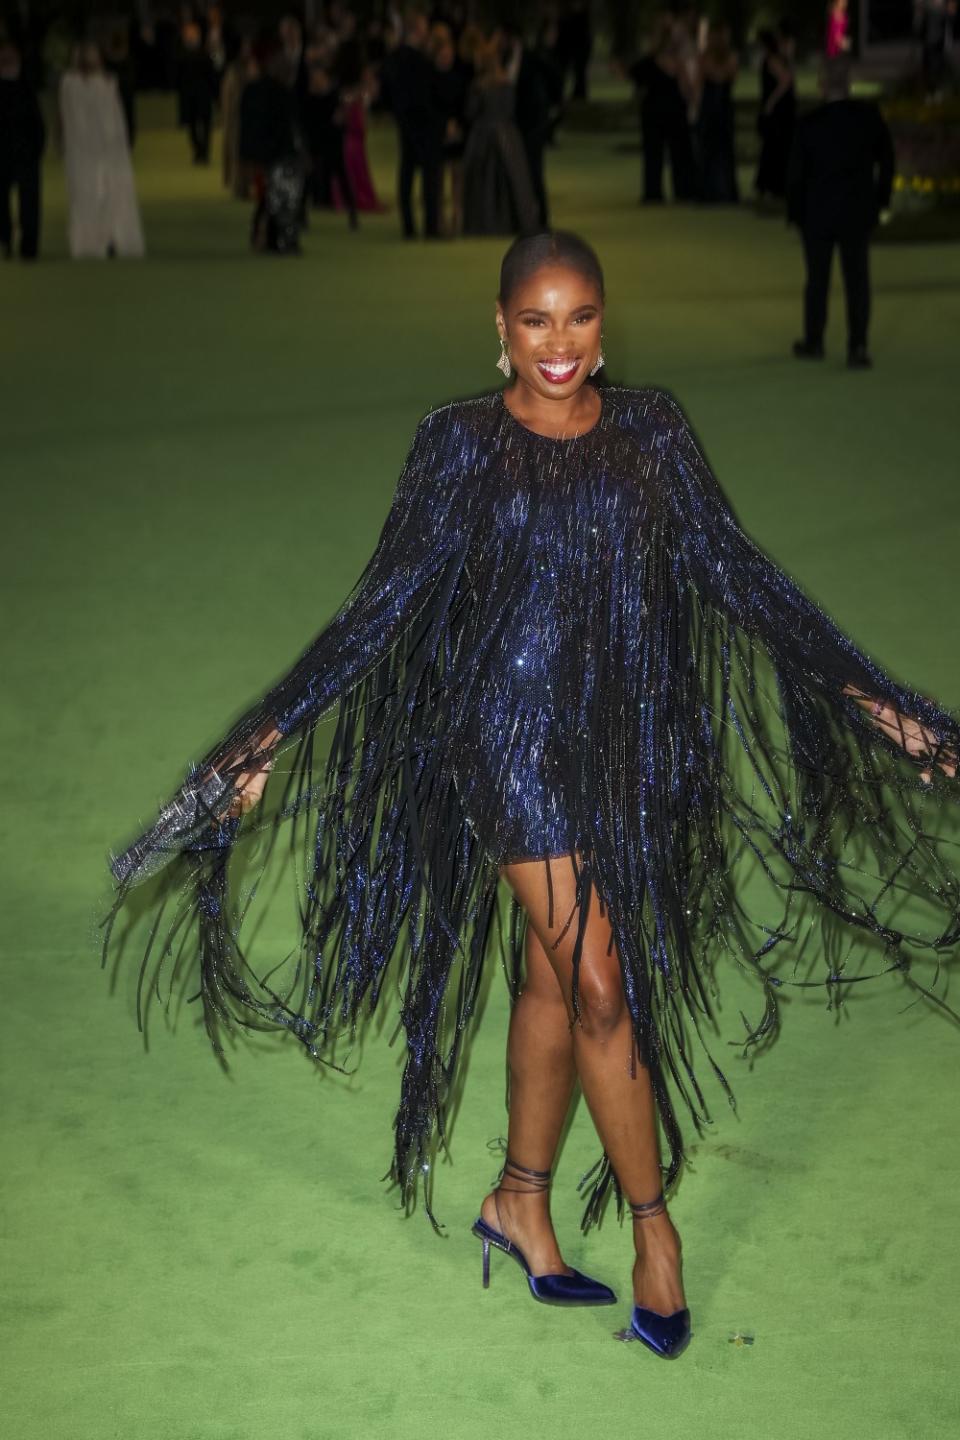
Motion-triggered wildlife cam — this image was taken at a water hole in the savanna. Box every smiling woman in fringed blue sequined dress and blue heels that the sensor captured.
[114,232,960,1356]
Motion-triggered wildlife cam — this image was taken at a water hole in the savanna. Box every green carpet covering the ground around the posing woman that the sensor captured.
[0,95,960,1440]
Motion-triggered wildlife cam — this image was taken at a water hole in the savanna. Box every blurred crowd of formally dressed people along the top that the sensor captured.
[0,0,938,269]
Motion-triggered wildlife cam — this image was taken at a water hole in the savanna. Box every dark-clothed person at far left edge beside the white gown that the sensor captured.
[0,39,46,261]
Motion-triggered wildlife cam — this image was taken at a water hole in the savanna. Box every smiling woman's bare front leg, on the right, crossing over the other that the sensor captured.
[504,857,685,1315]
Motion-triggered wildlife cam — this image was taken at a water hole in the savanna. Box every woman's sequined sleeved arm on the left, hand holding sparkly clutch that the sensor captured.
[111,406,461,886]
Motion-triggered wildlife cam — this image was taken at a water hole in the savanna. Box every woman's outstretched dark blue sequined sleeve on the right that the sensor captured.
[661,392,960,766]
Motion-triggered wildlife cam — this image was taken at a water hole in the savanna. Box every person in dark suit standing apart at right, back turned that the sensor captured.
[787,59,894,370]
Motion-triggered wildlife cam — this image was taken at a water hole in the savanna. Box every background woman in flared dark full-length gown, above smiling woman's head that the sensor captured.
[463,30,538,235]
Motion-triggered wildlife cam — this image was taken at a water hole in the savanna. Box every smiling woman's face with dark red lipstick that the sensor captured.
[497,262,603,400]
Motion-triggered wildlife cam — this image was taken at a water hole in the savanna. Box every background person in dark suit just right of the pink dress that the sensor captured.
[380,10,445,240]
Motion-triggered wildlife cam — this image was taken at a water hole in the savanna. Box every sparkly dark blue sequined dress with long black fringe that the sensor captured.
[108,387,960,1221]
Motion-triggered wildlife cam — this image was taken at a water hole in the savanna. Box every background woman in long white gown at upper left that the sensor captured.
[60,45,144,259]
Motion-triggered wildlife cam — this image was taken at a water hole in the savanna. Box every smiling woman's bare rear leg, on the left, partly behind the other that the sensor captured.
[481,924,577,1274]
